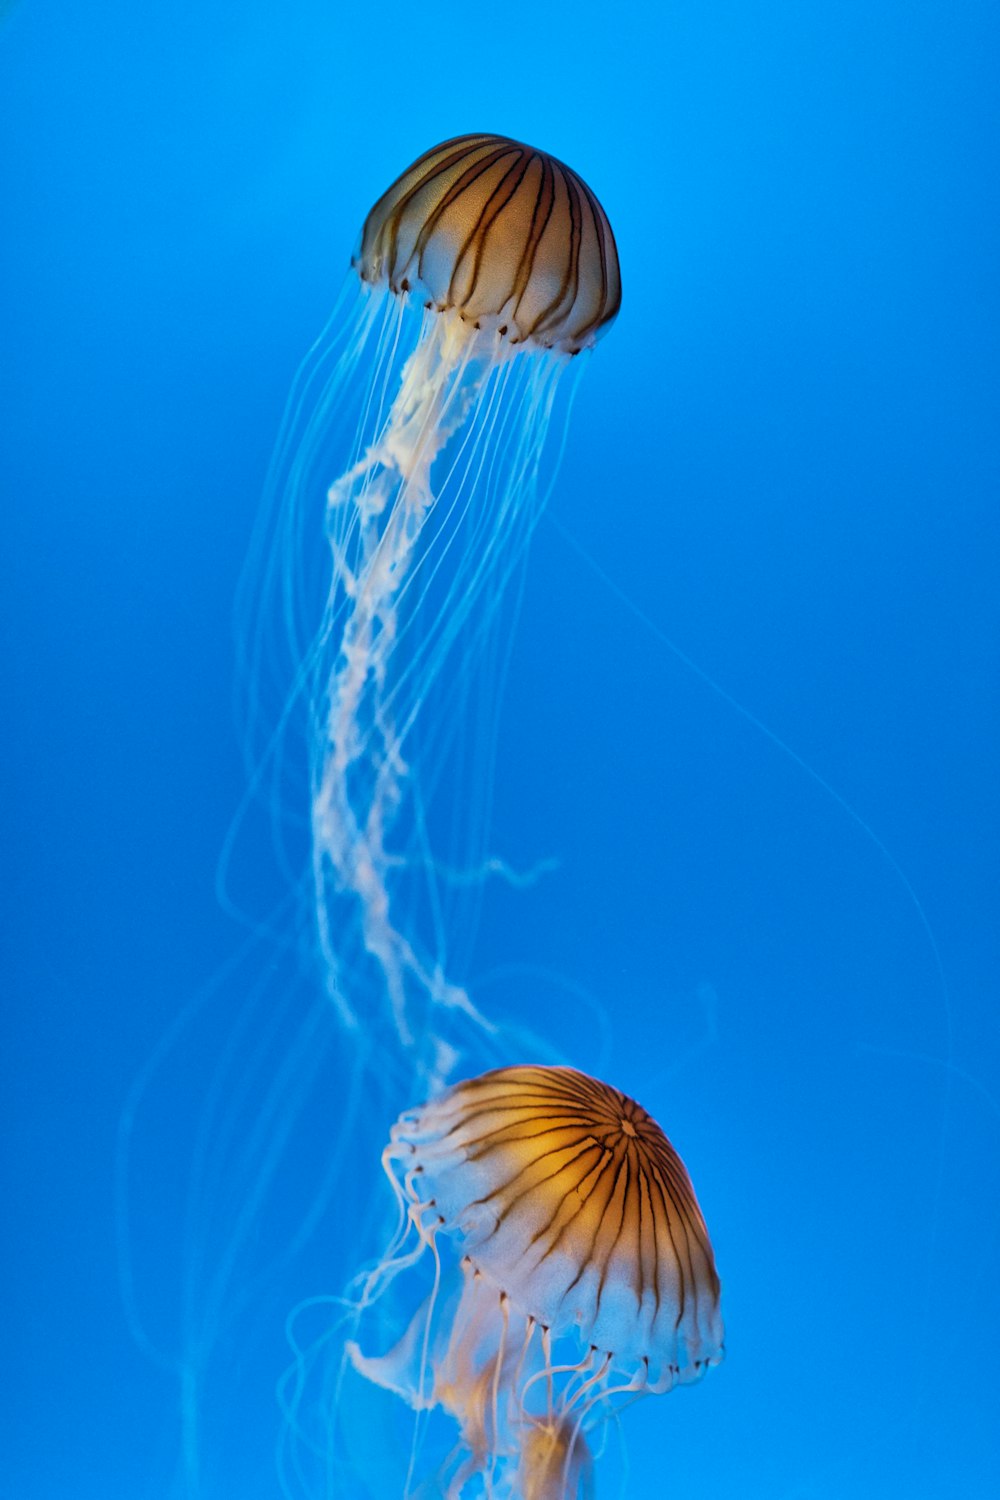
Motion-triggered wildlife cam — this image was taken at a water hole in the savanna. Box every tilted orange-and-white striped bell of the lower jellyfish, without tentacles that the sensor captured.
[393,1067,721,1389]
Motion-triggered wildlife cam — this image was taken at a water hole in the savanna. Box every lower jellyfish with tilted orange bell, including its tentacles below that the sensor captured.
[348,1065,723,1500]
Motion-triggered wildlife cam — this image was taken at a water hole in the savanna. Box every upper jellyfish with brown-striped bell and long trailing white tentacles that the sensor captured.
[240,135,621,1077]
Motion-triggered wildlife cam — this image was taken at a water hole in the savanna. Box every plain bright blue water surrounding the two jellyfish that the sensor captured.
[0,0,1000,1500]
